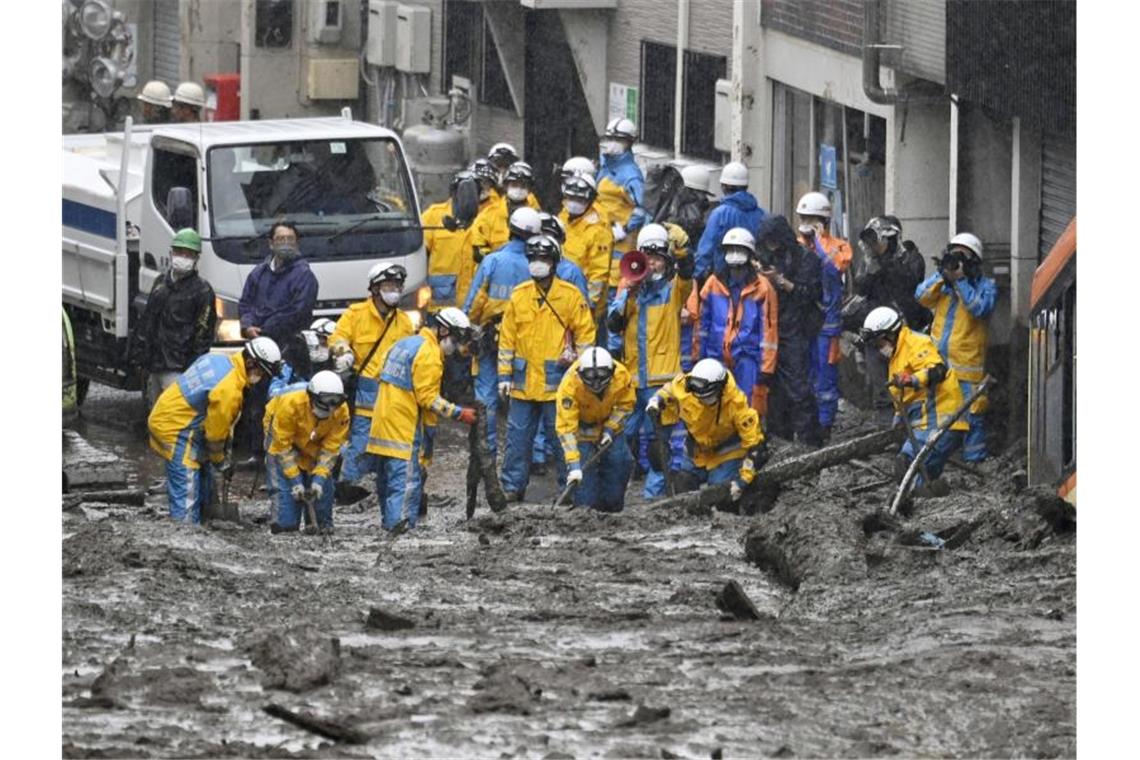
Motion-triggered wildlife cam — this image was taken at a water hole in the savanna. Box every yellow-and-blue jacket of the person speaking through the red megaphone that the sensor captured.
[611,276,693,387]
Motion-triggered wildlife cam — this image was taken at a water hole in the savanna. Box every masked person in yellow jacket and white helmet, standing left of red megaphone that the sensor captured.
[559,174,613,324]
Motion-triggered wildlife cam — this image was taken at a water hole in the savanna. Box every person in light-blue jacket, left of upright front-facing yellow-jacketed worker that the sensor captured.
[463,206,543,453]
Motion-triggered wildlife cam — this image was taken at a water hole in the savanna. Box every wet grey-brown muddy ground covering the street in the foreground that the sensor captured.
[62,386,1076,758]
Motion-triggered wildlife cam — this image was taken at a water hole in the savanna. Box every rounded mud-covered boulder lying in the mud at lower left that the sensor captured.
[246,626,341,694]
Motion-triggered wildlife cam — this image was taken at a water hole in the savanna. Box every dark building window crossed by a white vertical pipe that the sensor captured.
[640,40,728,161]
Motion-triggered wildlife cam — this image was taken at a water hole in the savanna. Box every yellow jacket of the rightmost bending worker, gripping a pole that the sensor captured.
[887,326,970,431]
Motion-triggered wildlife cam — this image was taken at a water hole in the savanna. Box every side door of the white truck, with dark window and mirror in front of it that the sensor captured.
[139,137,201,294]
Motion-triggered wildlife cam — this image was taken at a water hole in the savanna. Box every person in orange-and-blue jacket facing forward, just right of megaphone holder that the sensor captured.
[689,227,779,417]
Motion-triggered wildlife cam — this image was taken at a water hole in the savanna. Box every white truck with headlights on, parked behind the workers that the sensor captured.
[63,108,431,397]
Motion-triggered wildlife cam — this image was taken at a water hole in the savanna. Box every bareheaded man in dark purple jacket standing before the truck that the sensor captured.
[237,220,317,458]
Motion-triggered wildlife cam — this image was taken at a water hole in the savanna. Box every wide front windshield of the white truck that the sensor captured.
[207,138,422,262]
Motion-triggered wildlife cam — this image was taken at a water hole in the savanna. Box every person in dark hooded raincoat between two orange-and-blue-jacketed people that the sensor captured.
[756,216,823,448]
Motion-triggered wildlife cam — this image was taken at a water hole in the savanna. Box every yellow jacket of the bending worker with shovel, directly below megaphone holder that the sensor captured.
[554,360,637,469]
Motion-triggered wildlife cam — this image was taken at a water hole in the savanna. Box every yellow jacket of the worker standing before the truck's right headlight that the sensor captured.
[328,299,415,417]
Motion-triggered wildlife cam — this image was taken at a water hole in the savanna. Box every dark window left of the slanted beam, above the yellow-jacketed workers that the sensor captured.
[443,0,514,109]
